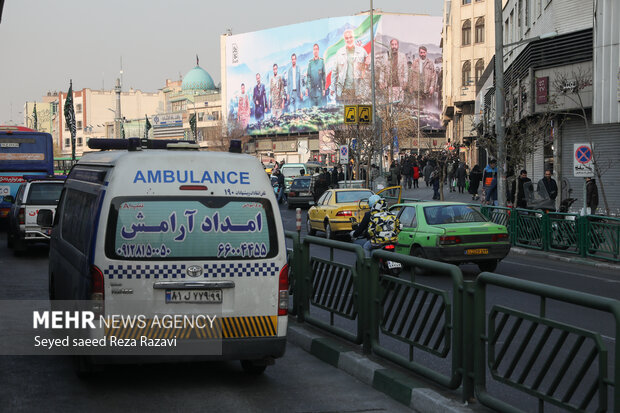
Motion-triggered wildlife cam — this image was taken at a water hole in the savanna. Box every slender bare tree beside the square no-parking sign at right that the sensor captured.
[553,68,612,215]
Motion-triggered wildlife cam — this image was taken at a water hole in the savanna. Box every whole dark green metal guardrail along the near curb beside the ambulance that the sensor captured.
[286,233,620,412]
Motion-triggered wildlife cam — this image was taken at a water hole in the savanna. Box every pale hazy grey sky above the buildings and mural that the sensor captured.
[0,0,443,125]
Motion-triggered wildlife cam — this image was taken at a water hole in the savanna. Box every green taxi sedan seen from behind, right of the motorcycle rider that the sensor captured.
[390,202,510,271]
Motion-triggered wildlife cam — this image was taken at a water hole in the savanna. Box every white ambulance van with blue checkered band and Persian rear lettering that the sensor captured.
[39,138,288,374]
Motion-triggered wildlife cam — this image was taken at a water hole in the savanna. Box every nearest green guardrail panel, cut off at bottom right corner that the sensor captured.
[468,273,620,412]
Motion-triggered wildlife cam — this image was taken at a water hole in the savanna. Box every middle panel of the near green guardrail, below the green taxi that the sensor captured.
[369,250,463,389]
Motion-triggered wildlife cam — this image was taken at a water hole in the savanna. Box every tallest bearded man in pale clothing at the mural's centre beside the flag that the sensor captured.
[331,29,370,102]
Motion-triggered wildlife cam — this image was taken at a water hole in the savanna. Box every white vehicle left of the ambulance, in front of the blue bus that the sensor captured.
[7,179,64,253]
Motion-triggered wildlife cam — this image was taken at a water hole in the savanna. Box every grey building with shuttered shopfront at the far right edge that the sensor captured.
[477,0,620,214]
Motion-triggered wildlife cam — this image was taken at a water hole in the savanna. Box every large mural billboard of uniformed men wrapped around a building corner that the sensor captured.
[224,14,442,135]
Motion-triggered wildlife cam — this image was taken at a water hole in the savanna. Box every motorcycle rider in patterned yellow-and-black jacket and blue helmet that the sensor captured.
[350,195,401,255]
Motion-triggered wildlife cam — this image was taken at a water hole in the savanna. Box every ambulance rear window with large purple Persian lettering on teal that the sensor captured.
[106,197,278,261]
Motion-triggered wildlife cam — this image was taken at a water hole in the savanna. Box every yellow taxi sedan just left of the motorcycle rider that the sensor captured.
[306,186,402,239]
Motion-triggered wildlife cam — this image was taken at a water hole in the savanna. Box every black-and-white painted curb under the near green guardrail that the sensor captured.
[288,321,473,413]
